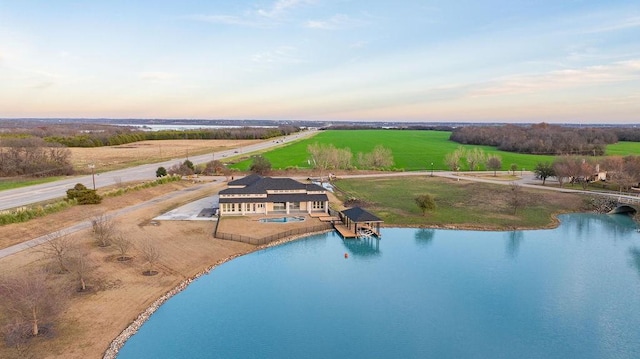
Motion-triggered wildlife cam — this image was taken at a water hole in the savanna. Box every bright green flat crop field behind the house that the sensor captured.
[232,130,553,171]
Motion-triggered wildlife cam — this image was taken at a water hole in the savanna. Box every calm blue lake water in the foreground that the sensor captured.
[119,215,640,359]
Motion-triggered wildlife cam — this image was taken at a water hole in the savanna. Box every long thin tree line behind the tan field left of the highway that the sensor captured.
[44,126,300,147]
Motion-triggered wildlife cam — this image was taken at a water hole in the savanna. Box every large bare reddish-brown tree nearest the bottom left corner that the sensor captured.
[0,271,64,336]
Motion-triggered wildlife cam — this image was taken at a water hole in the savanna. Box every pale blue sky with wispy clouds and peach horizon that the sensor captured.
[0,0,640,124]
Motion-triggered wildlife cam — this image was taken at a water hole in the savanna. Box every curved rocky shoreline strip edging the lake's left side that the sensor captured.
[102,229,332,359]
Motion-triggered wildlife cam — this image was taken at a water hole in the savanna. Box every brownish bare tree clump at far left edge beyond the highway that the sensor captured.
[0,137,73,177]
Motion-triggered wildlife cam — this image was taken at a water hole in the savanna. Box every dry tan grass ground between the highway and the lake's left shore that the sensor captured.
[0,183,255,358]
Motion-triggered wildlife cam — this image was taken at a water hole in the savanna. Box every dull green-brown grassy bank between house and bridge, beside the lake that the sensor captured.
[335,176,585,229]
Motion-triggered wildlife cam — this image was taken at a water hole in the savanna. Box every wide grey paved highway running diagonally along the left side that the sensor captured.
[0,131,317,211]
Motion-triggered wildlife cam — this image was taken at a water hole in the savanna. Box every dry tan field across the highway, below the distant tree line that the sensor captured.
[69,140,260,173]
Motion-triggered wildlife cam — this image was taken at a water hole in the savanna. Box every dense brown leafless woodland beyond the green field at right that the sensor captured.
[450,123,619,156]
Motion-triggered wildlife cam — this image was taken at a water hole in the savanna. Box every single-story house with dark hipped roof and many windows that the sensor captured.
[219,174,329,216]
